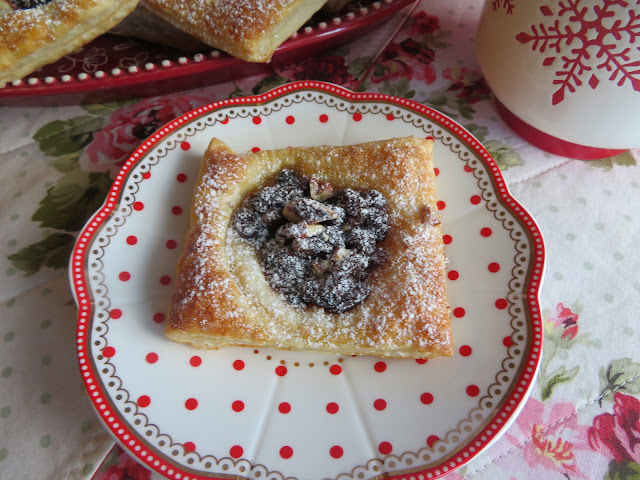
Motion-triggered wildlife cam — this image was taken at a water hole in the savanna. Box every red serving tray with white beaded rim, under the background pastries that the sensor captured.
[0,0,416,105]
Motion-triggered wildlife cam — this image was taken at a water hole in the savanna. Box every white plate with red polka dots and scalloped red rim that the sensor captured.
[70,82,544,480]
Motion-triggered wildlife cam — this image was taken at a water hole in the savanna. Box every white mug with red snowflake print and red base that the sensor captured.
[476,0,640,159]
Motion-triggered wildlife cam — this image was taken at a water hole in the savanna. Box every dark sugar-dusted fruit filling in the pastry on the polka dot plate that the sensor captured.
[232,170,389,313]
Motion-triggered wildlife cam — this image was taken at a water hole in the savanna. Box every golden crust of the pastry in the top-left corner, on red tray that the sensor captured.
[0,0,139,87]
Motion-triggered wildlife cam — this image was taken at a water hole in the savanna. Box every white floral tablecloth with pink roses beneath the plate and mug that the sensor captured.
[0,0,640,480]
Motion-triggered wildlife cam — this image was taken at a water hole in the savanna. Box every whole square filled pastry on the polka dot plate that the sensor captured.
[165,137,453,358]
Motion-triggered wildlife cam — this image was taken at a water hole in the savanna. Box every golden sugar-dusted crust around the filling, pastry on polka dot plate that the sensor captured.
[165,137,453,358]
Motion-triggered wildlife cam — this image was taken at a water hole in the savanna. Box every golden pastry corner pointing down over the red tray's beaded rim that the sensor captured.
[143,0,327,62]
